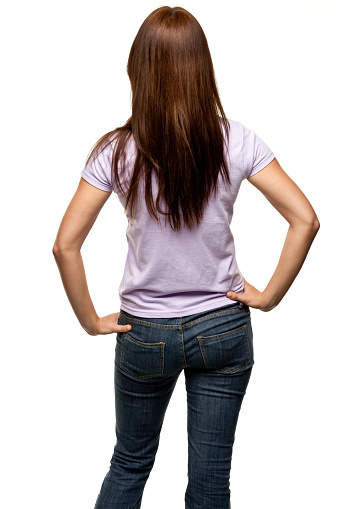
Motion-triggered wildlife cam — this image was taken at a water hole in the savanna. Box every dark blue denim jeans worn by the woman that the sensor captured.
[95,302,254,509]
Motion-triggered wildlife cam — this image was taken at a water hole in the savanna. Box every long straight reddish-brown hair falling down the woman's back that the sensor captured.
[86,7,230,231]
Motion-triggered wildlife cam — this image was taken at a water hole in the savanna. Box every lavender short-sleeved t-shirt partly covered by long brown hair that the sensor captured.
[81,119,275,318]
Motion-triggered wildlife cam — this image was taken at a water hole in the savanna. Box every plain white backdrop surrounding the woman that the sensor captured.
[0,0,339,509]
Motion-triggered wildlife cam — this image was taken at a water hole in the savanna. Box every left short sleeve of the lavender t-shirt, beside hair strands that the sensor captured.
[81,144,115,192]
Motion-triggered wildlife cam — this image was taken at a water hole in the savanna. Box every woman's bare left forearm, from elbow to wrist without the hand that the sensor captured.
[53,250,98,334]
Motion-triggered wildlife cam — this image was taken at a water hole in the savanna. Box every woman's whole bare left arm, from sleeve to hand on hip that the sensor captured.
[53,178,131,336]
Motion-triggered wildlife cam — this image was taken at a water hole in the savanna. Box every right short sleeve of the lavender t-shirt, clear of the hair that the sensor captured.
[243,126,275,178]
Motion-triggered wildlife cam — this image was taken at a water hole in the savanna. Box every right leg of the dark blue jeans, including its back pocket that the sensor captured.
[185,307,254,508]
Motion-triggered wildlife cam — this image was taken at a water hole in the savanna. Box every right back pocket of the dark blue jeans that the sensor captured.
[198,324,252,373]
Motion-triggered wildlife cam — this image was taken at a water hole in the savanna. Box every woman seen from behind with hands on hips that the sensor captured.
[53,7,319,509]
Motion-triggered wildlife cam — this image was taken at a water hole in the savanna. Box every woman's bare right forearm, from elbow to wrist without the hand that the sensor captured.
[263,221,319,308]
